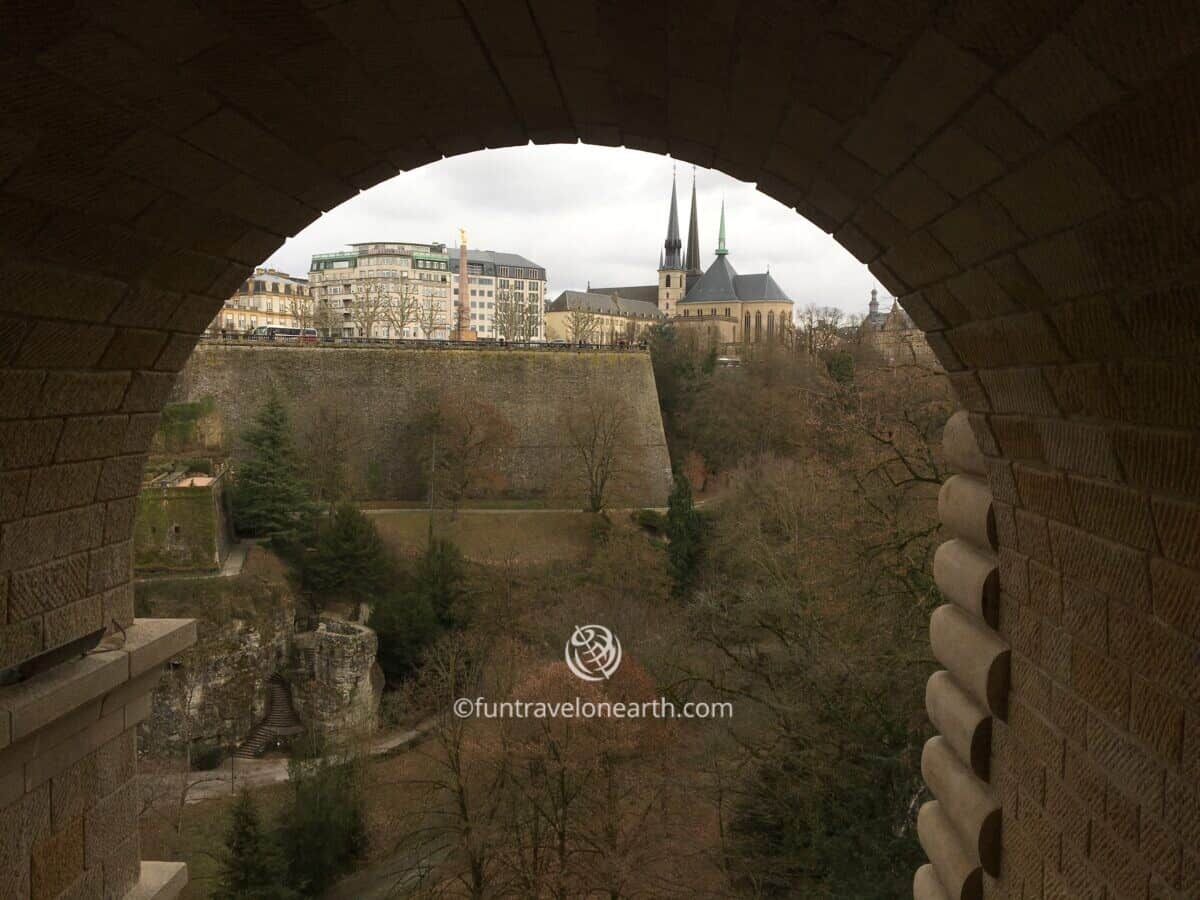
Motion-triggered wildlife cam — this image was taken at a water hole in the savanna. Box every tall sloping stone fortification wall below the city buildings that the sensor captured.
[172,344,671,505]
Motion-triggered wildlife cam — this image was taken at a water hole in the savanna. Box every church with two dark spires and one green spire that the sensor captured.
[589,173,793,346]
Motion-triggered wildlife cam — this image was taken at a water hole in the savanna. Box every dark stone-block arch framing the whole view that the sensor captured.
[0,0,1200,896]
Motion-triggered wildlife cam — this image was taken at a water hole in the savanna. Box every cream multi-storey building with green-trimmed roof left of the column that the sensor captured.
[308,241,451,340]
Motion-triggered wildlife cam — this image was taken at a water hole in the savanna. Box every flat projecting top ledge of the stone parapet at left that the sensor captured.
[0,619,196,748]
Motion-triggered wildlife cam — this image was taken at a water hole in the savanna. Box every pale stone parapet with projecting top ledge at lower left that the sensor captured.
[0,619,196,900]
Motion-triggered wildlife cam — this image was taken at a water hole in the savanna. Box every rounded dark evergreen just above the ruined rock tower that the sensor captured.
[302,503,392,607]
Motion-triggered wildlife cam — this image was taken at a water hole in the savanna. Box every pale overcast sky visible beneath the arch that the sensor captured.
[265,144,887,313]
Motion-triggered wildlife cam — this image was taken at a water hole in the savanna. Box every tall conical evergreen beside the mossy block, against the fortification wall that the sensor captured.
[233,389,313,540]
